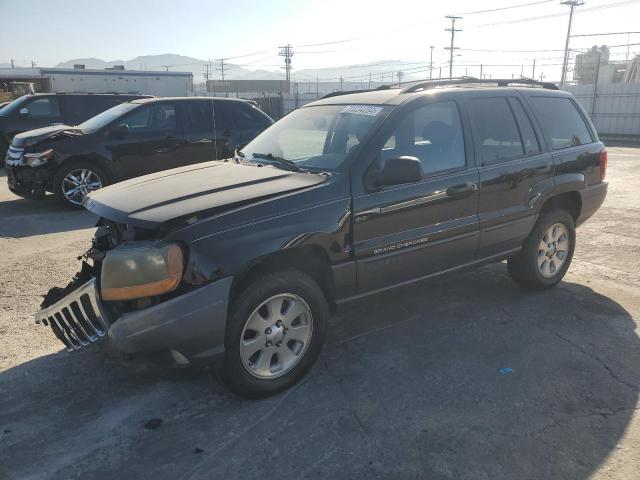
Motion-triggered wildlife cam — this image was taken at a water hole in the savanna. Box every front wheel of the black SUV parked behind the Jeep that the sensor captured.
[53,162,109,208]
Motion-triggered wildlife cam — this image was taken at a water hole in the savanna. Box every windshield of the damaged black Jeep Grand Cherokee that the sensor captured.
[242,105,388,171]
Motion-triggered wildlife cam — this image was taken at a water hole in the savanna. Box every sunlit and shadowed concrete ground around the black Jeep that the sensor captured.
[0,147,640,480]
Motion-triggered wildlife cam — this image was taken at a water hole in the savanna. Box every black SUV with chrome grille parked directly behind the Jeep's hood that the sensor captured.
[6,97,273,207]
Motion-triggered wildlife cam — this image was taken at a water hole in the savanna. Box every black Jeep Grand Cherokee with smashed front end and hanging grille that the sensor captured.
[36,79,607,397]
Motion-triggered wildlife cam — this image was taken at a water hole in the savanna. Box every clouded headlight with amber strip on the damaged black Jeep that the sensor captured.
[100,242,184,300]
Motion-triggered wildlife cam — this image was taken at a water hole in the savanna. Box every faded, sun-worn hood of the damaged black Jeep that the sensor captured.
[83,161,326,228]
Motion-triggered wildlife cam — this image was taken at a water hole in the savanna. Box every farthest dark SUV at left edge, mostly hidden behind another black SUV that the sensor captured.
[0,93,150,166]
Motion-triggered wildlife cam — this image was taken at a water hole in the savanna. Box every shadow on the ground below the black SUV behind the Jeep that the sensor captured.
[0,195,97,238]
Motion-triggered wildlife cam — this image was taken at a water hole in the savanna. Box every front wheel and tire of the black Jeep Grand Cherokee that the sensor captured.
[224,270,329,398]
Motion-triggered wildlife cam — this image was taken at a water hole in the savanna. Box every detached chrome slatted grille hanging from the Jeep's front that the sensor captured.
[36,279,109,352]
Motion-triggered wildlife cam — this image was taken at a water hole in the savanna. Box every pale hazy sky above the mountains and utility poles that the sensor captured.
[0,0,640,81]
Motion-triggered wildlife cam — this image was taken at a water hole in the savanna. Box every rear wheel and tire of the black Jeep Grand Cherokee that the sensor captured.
[507,209,576,290]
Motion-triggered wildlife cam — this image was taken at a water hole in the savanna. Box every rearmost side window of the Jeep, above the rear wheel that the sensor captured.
[531,97,594,150]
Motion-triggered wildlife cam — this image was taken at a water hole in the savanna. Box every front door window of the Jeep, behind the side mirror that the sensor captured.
[380,101,466,176]
